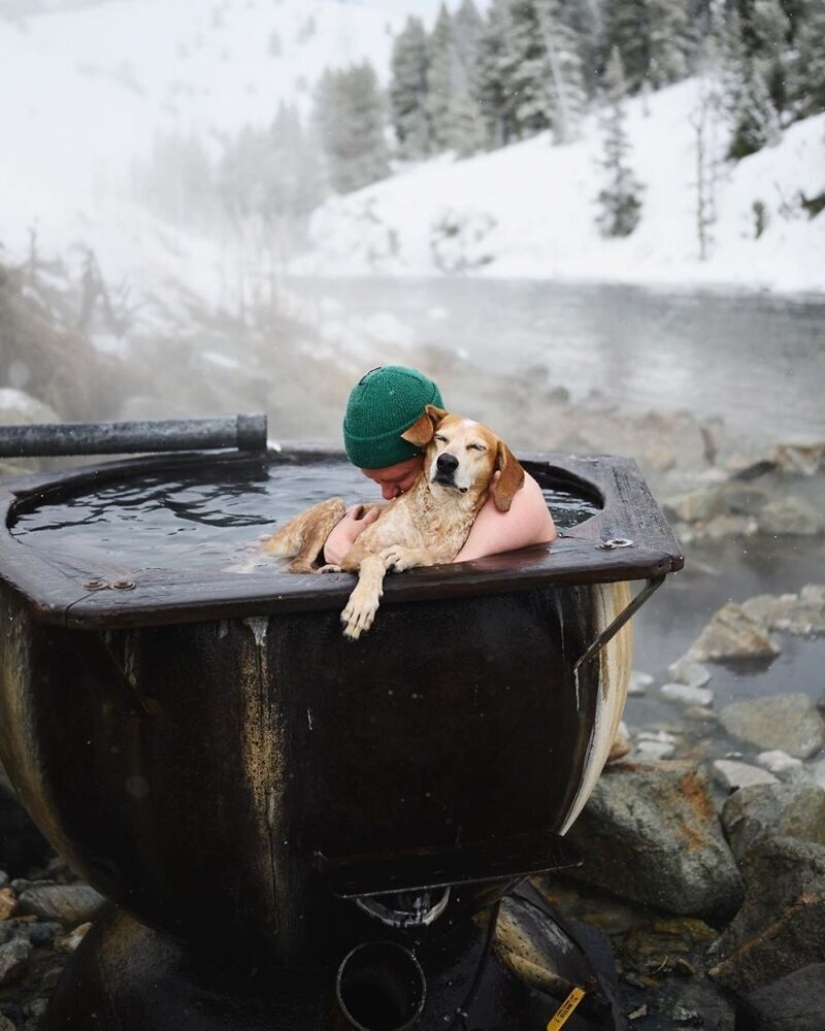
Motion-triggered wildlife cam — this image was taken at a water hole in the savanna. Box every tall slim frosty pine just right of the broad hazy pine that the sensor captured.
[390,18,431,159]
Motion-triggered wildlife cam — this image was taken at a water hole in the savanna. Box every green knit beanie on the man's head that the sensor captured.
[343,365,443,469]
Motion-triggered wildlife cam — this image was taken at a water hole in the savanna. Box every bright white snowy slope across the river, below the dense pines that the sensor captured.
[295,80,825,291]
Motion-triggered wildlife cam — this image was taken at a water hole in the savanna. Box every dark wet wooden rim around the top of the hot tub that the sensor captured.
[0,446,684,630]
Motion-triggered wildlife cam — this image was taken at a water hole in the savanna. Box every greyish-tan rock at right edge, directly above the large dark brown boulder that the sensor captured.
[721,774,825,859]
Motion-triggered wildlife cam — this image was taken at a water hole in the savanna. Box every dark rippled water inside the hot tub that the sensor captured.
[11,463,598,571]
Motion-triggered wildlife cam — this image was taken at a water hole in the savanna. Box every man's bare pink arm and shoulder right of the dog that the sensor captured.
[454,474,558,562]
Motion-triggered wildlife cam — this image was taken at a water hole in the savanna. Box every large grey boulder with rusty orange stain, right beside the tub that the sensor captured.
[568,761,743,922]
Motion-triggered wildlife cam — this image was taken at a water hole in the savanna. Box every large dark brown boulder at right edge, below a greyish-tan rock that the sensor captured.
[710,837,825,994]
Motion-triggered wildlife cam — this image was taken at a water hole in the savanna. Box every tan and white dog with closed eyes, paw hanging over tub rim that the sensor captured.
[264,404,525,640]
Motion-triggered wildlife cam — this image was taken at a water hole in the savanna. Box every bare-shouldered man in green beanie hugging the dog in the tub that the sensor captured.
[324,365,557,564]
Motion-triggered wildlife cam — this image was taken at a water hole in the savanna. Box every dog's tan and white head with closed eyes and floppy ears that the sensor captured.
[401,404,524,512]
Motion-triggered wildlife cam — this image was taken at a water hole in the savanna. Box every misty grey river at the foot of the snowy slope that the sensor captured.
[295,274,825,443]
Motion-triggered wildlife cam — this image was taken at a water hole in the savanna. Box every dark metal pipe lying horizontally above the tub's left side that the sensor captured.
[0,414,266,458]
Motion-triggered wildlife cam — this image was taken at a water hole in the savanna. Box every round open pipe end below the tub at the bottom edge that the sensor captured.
[335,941,427,1031]
